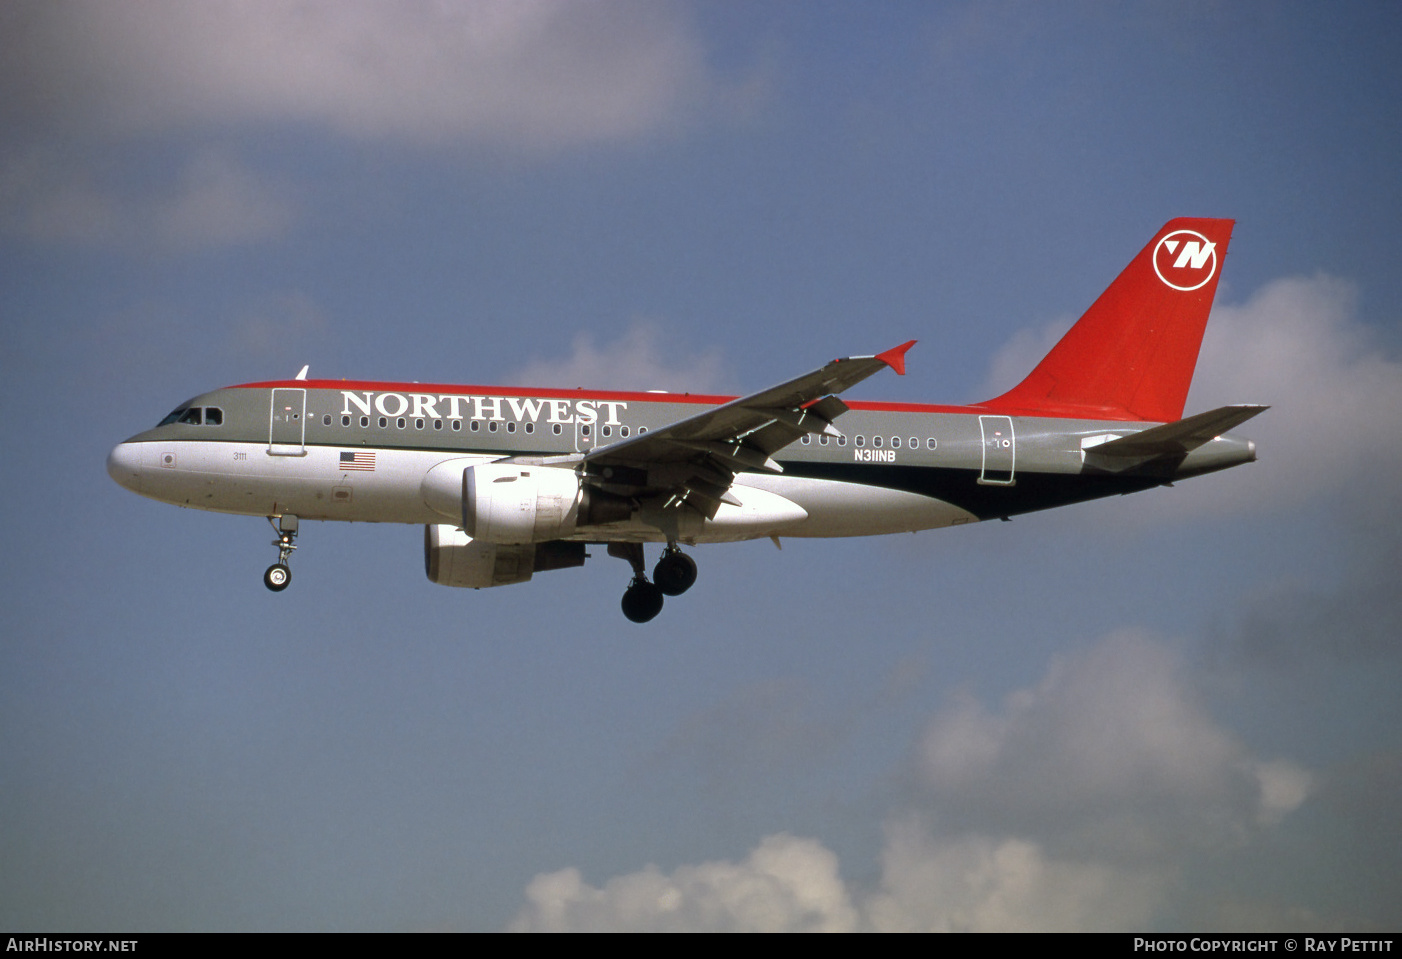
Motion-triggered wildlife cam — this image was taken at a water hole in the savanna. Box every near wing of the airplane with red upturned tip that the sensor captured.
[583,339,916,519]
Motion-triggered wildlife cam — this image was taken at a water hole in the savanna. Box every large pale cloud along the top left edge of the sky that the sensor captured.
[0,0,707,147]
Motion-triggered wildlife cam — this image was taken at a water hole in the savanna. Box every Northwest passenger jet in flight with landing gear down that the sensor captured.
[107,219,1266,623]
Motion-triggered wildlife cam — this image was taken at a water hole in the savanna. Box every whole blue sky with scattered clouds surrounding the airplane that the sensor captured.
[0,0,1402,931]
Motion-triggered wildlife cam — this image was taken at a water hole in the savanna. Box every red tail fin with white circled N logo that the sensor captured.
[981,219,1234,422]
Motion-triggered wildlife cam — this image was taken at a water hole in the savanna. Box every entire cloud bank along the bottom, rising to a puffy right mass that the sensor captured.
[512,634,1314,931]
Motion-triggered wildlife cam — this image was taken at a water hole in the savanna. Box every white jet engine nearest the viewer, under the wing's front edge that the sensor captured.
[463,463,632,545]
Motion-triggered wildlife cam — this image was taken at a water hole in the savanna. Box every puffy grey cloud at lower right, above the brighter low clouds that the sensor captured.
[918,632,1309,861]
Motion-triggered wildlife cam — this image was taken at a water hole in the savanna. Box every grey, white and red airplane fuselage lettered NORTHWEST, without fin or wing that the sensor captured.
[108,380,1255,543]
